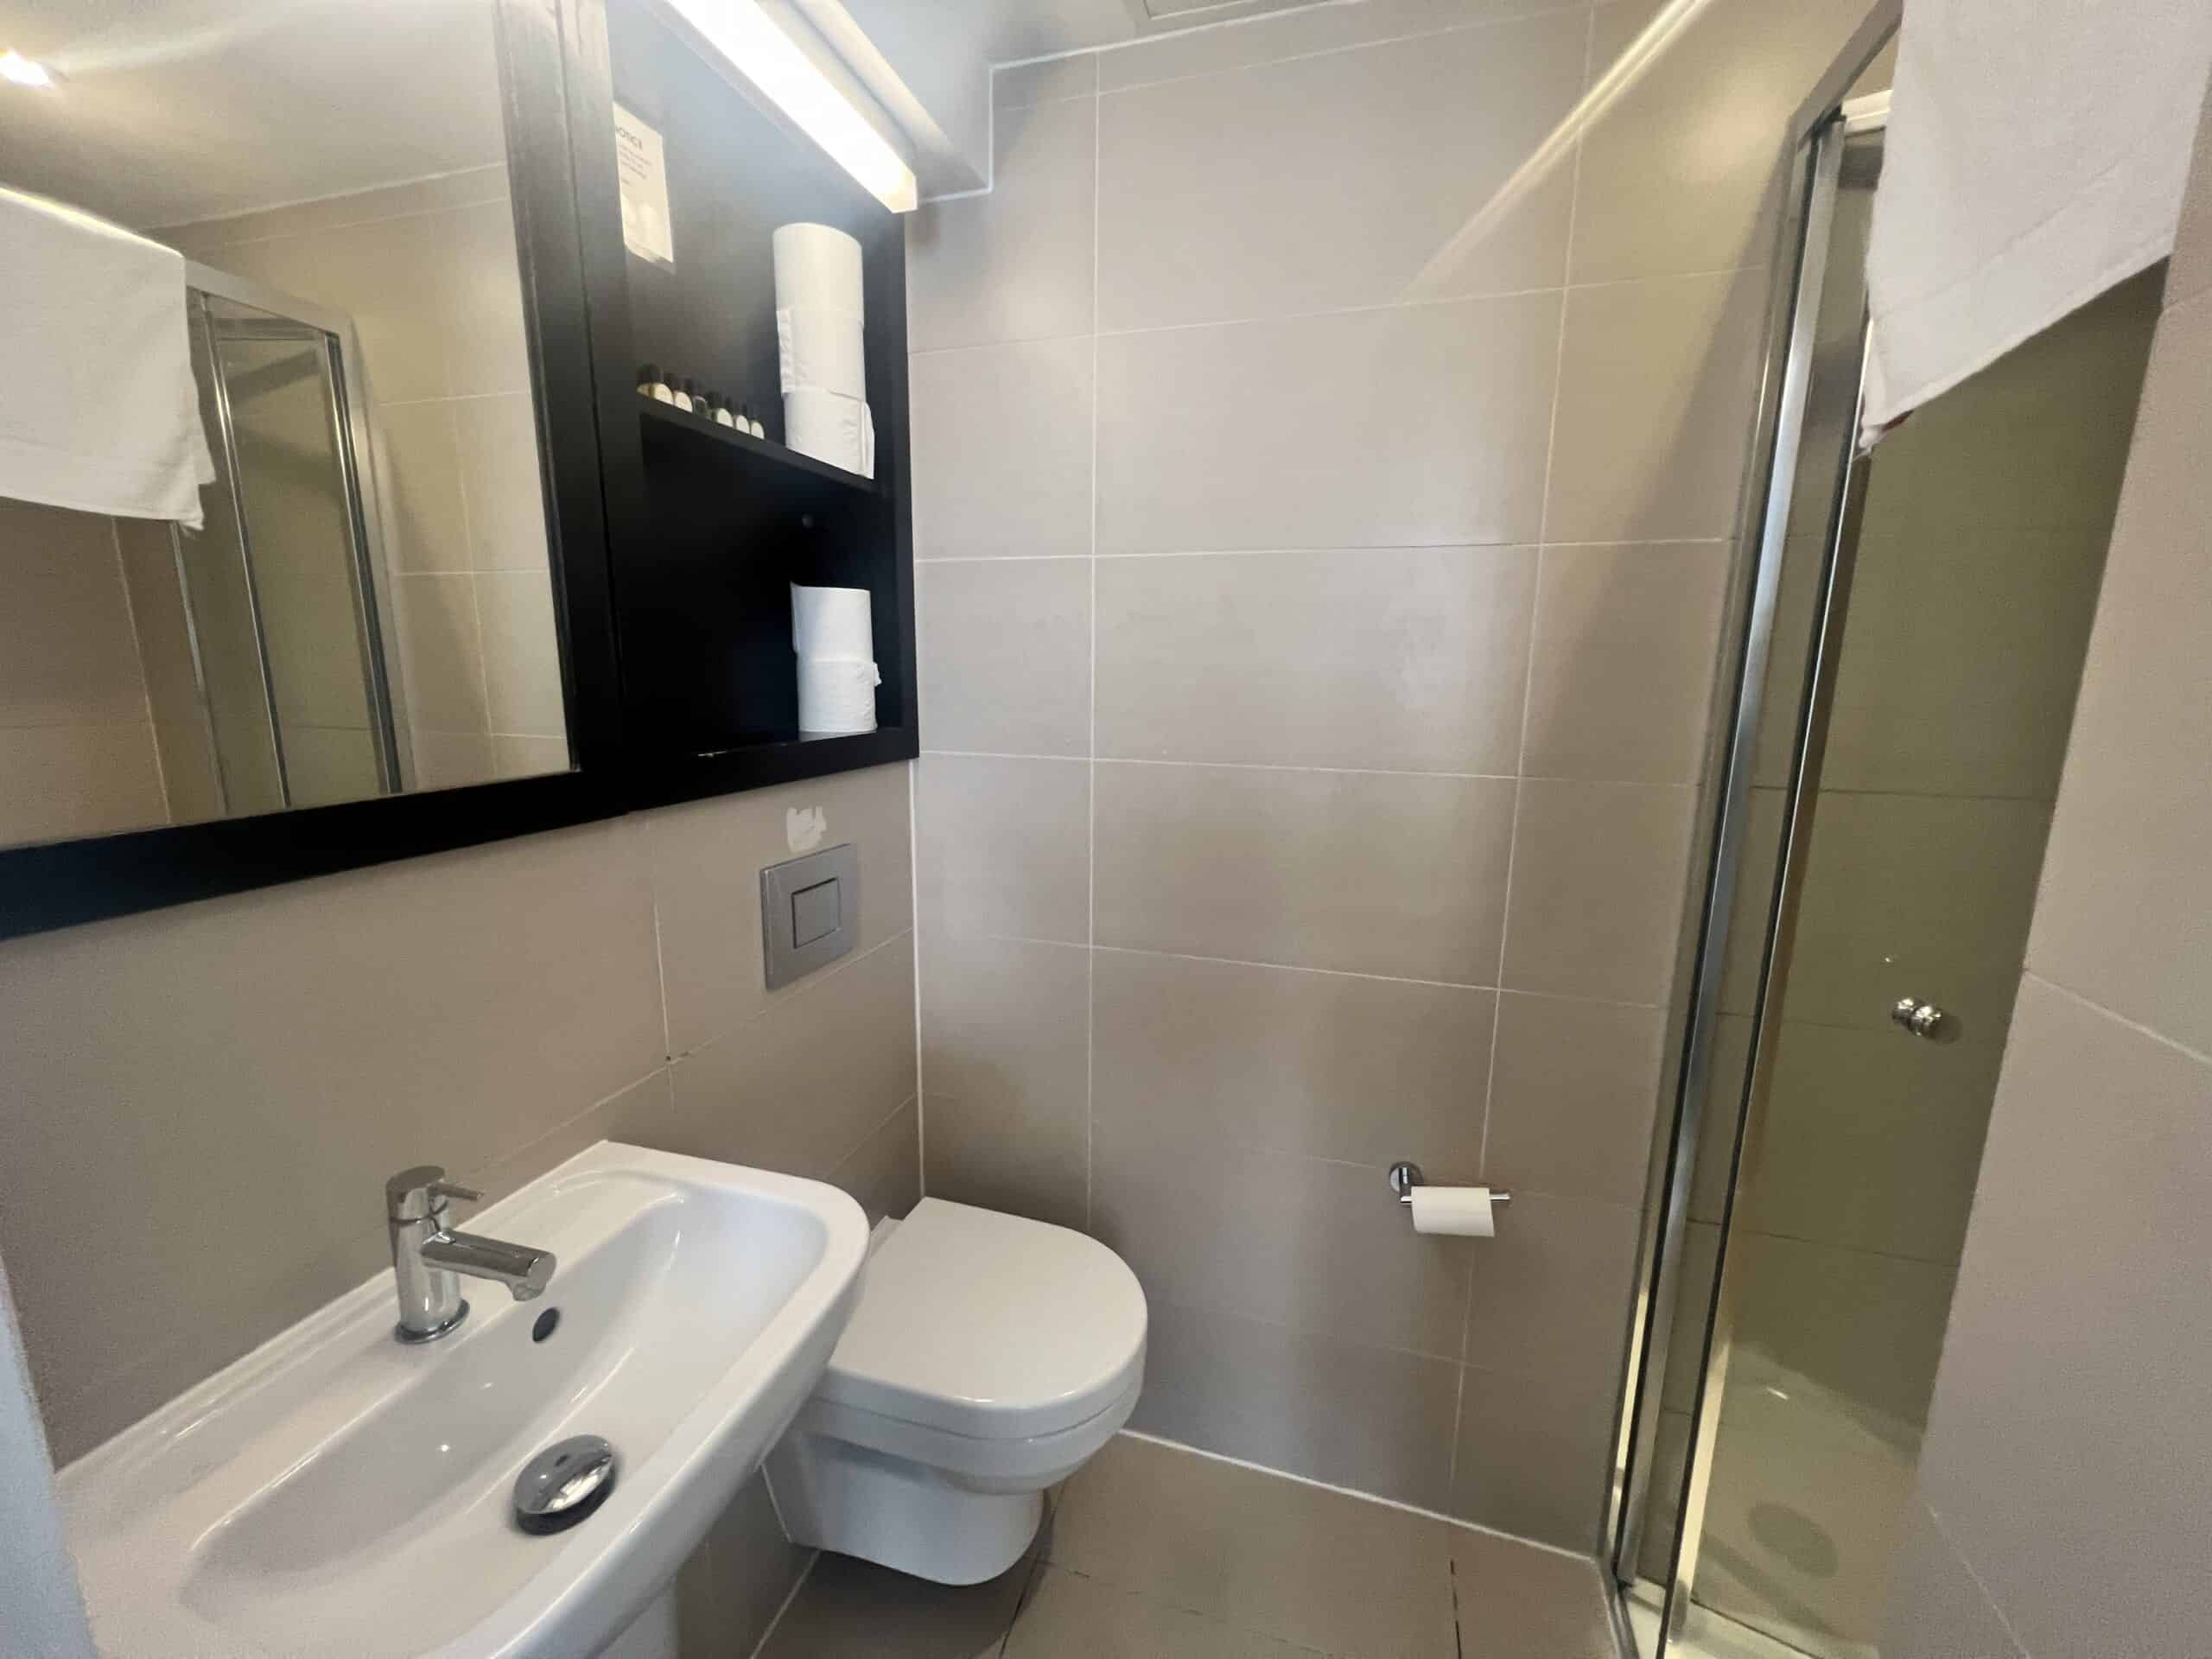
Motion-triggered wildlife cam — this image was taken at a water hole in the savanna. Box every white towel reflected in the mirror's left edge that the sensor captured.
[0,186,214,531]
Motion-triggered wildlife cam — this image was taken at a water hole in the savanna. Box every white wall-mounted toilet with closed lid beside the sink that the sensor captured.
[767,1199,1146,1584]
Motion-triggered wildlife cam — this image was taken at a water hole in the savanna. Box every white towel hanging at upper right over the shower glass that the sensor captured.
[1860,0,2212,442]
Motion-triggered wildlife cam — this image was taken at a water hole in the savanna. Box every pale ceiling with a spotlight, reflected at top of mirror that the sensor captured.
[0,0,506,228]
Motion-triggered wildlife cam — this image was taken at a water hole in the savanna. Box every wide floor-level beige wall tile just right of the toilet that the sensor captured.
[1130,1296,1460,1510]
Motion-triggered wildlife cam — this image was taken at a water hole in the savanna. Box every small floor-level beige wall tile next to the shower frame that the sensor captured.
[1451,1365,1615,1551]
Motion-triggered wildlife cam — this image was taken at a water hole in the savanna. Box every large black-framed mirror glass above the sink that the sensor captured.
[0,0,570,845]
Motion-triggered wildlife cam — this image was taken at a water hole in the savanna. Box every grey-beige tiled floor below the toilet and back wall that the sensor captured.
[761,1435,1615,1659]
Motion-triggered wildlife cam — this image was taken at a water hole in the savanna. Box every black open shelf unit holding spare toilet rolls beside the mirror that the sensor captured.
[573,0,920,805]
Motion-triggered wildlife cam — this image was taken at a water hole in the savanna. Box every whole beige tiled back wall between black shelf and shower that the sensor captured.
[909,0,1863,1546]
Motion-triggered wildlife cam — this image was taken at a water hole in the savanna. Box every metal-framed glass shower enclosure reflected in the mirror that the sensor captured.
[157,265,407,817]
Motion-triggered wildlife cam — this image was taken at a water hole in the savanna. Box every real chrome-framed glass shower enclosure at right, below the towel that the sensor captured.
[1612,16,2161,1659]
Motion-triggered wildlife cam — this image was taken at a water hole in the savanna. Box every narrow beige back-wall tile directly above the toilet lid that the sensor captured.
[920,933,1090,1228]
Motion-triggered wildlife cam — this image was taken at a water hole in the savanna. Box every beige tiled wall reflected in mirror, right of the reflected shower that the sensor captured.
[159,166,569,787]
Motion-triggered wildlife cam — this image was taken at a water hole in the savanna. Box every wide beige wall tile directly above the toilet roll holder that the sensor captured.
[1093,951,1493,1181]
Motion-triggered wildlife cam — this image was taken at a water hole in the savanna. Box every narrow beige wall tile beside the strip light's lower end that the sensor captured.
[907,98,1097,352]
